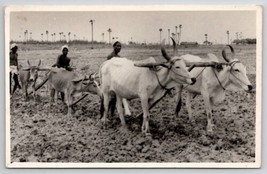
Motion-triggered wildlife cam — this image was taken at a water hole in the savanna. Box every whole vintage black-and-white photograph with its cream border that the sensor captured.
[5,5,262,168]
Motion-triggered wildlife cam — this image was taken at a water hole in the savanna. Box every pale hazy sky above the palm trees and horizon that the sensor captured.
[10,11,256,43]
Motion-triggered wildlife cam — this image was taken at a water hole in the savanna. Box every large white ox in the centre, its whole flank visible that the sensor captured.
[100,43,196,135]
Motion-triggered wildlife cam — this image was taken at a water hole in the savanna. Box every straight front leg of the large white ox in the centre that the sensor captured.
[141,97,150,135]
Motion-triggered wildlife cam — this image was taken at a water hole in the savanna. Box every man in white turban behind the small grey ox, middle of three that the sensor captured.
[52,45,72,71]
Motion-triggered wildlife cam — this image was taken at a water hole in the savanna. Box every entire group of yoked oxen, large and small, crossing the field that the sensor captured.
[11,40,252,135]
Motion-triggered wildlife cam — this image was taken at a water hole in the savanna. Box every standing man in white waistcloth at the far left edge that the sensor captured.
[9,43,21,94]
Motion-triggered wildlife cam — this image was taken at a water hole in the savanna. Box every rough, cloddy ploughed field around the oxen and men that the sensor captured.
[10,45,256,163]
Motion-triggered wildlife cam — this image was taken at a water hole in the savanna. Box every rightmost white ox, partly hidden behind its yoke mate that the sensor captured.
[176,45,252,133]
